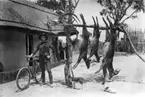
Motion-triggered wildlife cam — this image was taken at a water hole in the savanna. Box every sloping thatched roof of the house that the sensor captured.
[0,0,76,35]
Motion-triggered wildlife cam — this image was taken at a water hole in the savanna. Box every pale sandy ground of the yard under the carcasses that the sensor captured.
[0,54,145,97]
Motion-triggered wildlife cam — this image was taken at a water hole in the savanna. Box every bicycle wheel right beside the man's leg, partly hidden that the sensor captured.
[34,64,41,83]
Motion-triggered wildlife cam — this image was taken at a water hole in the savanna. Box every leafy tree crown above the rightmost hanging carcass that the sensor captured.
[97,0,145,23]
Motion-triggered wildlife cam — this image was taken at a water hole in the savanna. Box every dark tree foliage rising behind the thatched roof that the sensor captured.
[36,0,80,23]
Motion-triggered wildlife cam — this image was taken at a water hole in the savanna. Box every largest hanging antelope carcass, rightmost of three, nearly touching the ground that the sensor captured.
[95,17,120,84]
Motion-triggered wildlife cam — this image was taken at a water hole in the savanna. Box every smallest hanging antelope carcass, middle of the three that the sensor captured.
[88,16,101,62]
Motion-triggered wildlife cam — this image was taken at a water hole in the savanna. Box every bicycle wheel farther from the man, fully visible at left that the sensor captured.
[16,67,30,90]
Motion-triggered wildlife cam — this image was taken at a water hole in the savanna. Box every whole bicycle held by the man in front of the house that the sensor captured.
[16,56,41,90]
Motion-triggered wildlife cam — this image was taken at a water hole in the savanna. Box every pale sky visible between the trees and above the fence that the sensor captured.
[29,0,145,41]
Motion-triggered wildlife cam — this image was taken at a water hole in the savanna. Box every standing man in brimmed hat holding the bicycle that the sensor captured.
[28,33,54,85]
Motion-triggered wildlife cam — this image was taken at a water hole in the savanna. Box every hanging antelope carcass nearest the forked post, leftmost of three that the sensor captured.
[73,14,90,69]
